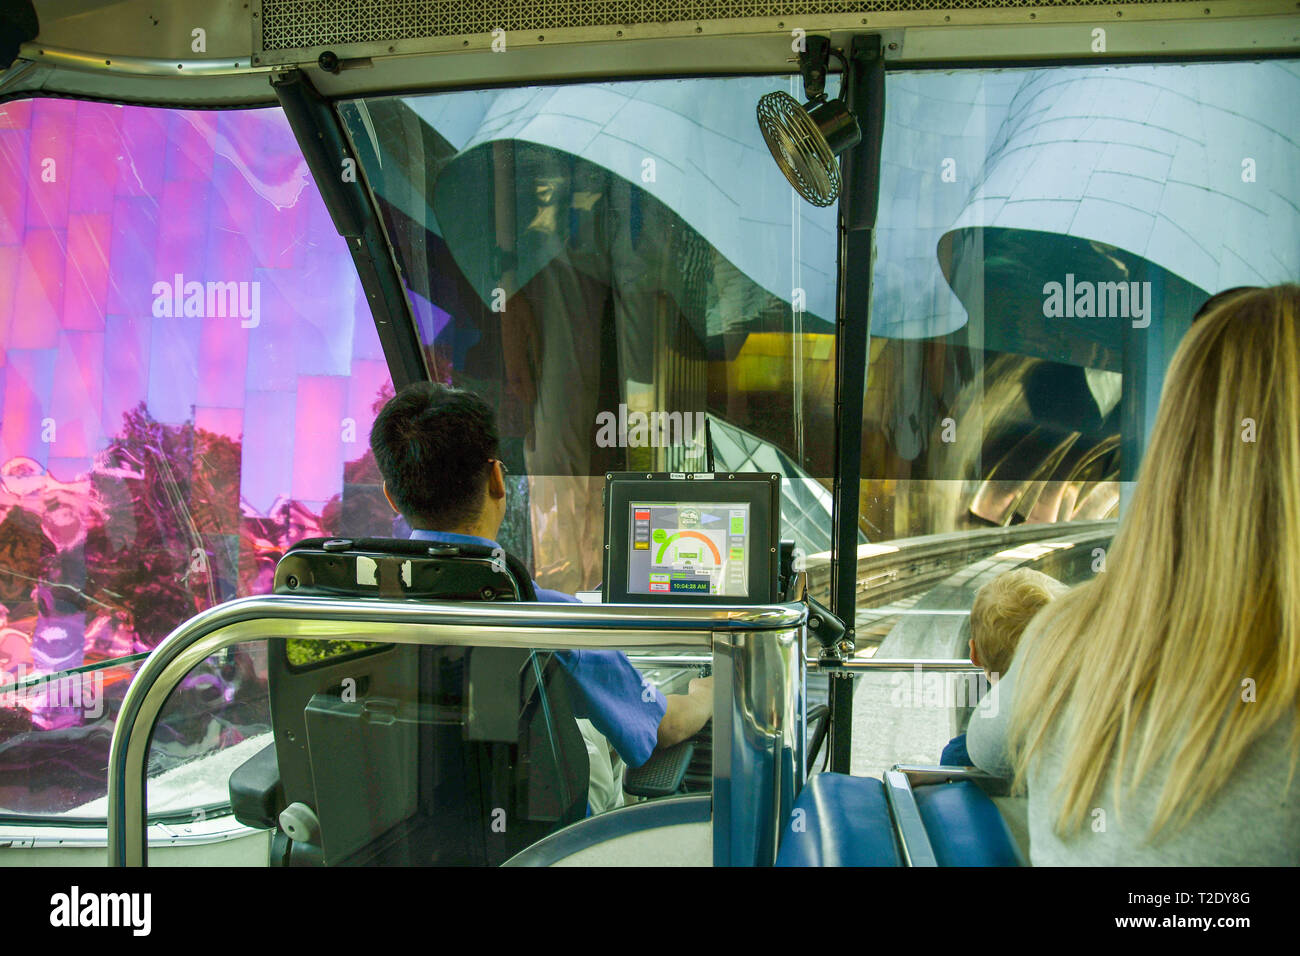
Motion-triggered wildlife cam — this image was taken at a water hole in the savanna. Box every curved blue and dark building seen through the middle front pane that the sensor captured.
[342,78,835,592]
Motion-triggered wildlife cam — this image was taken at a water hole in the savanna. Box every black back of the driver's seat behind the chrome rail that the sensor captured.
[268,538,588,865]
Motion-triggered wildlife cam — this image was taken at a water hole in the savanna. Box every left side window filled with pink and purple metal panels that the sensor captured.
[0,99,393,816]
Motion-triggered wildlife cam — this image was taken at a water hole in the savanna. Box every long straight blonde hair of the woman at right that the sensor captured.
[1009,285,1300,839]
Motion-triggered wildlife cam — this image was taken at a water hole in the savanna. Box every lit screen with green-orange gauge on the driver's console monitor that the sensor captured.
[628,501,754,600]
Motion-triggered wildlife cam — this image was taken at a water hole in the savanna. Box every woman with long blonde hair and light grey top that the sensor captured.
[967,285,1300,866]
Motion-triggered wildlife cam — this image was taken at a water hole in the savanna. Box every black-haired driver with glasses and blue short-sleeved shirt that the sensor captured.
[371,382,712,805]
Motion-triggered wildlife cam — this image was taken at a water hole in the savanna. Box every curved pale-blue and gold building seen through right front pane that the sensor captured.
[862,61,1300,540]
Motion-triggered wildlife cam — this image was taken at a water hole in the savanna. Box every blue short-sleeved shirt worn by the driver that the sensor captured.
[411,529,668,767]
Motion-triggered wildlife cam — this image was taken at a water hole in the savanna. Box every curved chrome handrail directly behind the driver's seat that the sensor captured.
[108,594,807,866]
